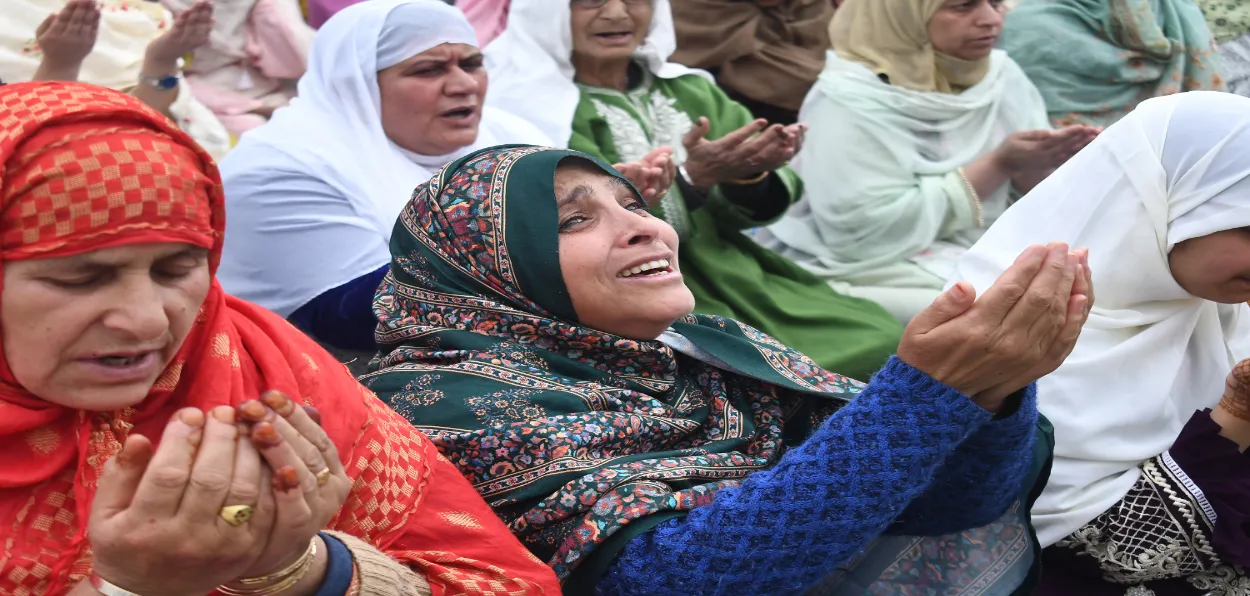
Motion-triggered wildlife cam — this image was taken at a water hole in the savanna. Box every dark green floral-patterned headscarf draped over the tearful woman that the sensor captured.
[364,146,860,592]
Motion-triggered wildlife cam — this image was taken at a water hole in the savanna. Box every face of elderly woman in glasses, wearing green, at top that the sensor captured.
[569,0,651,61]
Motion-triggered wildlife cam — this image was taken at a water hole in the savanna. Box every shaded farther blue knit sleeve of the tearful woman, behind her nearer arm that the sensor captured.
[888,385,1038,536]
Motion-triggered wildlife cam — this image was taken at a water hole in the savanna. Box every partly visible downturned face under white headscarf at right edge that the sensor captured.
[1168,227,1250,304]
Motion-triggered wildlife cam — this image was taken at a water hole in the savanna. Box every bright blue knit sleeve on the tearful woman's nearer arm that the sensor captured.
[596,357,1005,596]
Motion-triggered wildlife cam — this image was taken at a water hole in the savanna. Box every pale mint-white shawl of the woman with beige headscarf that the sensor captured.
[758,50,1050,279]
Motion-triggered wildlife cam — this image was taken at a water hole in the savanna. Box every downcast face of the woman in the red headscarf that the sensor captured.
[0,244,210,411]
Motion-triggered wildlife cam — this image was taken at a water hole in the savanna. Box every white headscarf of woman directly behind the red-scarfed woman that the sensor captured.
[218,0,549,316]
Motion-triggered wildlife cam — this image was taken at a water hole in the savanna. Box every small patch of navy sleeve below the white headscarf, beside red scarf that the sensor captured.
[288,265,390,351]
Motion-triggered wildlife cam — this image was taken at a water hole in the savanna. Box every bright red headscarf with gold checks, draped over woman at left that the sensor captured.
[0,82,559,595]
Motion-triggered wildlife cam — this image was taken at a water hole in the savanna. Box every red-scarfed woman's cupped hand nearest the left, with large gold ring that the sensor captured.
[88,406,281,595]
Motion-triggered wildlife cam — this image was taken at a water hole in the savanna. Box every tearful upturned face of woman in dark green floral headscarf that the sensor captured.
[555,160,695,340]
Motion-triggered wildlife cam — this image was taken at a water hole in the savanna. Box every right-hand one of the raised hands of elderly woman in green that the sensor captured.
[683,117,808,190]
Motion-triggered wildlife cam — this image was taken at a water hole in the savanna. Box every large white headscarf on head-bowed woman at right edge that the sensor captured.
[955,91,1250,545]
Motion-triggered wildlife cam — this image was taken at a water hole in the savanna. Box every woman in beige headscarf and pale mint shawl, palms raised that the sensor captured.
[756,0,1096,322]
